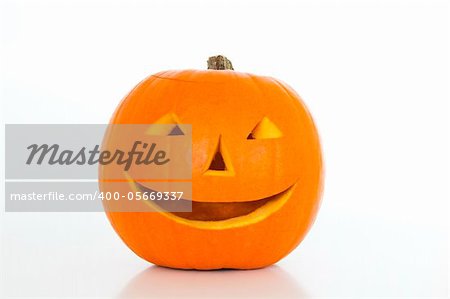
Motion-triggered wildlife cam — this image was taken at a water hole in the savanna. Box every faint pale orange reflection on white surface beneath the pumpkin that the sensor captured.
[119,266,306,298]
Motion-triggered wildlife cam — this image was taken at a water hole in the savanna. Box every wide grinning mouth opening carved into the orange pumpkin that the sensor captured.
[134,181,294,222]
